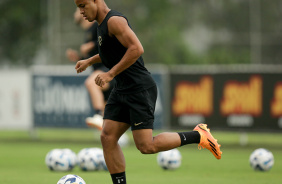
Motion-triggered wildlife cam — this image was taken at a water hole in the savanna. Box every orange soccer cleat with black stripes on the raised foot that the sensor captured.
[194,124,222,159]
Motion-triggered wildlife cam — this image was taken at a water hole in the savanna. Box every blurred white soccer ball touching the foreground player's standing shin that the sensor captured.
[77,148,107,171]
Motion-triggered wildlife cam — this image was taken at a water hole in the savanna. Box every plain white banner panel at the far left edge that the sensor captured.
[0,70,32,130]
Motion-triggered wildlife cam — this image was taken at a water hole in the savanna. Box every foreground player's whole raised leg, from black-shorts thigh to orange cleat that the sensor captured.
[130,87,221,159]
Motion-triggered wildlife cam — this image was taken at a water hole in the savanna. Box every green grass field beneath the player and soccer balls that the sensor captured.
[0,129,282,184]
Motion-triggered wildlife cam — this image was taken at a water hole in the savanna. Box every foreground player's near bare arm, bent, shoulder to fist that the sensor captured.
[95,16,144,87]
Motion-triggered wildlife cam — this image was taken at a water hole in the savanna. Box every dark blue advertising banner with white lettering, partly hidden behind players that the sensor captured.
[32,68,164,129]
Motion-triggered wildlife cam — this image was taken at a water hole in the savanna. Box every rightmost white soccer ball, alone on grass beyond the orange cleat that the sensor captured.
[249,148,274,171]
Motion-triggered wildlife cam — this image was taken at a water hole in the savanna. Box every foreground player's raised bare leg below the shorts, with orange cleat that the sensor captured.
[132,124,222,159]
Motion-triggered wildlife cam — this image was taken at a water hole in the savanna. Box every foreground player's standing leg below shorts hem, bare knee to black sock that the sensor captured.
[101,119,130,184]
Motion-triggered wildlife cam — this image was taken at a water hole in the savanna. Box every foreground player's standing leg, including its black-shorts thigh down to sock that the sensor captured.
[101,91,130,184]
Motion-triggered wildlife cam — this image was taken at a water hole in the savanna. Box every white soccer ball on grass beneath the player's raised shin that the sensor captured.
[157,148,182,170]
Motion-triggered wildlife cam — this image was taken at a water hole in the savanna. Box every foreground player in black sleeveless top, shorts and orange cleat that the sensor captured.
[74,0,222,184]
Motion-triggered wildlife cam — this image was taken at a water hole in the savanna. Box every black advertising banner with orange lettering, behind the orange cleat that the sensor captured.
[170,72,282,131]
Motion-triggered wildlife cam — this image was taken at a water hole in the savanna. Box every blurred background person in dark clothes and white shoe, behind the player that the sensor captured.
[66,8,112,130]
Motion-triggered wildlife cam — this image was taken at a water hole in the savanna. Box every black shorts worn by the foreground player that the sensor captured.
[104,86,158,130]
